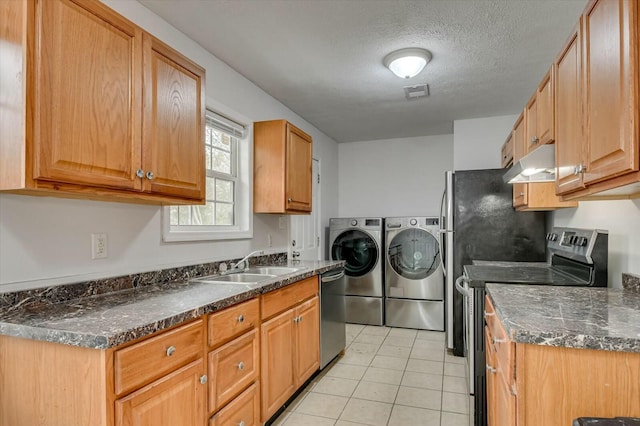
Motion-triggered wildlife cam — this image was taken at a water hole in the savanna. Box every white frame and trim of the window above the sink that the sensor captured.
[161,100,253,242]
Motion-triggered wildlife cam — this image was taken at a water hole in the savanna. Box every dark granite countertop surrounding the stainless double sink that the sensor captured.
[0,261,344,349]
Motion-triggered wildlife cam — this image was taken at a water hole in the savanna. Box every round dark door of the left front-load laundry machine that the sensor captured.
[331,229,380,277]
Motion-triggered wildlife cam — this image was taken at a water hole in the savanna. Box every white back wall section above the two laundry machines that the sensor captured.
[339,135,453,217]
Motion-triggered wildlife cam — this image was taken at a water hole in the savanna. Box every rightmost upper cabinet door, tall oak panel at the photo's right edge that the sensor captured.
[582,0,640,184]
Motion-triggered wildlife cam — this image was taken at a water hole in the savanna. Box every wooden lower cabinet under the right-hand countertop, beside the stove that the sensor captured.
[485,298,640,426]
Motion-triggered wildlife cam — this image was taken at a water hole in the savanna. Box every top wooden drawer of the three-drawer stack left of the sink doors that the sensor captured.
[208,297,260,347]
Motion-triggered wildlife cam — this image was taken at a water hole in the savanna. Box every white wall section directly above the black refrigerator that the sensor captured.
[453,115,518,170]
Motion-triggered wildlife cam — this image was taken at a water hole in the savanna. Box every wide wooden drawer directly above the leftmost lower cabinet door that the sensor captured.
[114,320,204,395]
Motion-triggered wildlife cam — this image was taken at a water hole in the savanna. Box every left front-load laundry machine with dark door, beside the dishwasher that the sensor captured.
[329,217,384,325]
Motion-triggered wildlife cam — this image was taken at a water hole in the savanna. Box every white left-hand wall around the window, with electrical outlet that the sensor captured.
[0,0,339,292]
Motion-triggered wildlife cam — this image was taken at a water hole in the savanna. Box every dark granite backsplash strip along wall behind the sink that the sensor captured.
[0,252,287,312]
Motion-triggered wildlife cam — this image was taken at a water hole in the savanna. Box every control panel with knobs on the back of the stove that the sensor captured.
[547,228,608,263]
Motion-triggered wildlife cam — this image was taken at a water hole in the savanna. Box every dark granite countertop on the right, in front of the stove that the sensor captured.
[486,284,640,352]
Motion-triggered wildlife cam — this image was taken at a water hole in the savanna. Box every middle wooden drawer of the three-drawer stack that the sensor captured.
[209,329,260,412]
